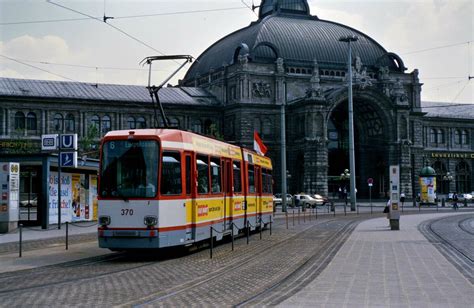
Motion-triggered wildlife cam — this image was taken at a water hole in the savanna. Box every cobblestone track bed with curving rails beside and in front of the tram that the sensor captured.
[0,217,362,307]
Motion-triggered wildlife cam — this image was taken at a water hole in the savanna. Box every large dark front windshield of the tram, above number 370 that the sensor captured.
[99,139,159,200]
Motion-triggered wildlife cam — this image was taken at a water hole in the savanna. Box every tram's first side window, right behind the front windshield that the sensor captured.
[160,152,182,195]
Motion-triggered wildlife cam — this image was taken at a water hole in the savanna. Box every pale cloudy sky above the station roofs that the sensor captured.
[0,0,474,104]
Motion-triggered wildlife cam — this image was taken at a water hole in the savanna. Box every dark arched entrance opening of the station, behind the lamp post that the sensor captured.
[327,97,392,198]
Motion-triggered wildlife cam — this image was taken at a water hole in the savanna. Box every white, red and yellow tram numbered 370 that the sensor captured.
[98,129,273,250]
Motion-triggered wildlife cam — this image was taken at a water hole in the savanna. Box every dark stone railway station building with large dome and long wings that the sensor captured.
[0,0,474,226]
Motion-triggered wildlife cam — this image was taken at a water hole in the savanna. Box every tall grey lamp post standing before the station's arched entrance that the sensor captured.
[339,35,358,211]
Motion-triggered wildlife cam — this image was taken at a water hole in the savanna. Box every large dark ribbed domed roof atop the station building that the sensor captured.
[184,0,404,82]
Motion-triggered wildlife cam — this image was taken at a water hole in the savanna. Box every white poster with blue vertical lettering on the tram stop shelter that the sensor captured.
[48,172,72,224]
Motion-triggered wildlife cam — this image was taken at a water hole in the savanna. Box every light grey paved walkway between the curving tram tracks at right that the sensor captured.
[280,212,474,308]
